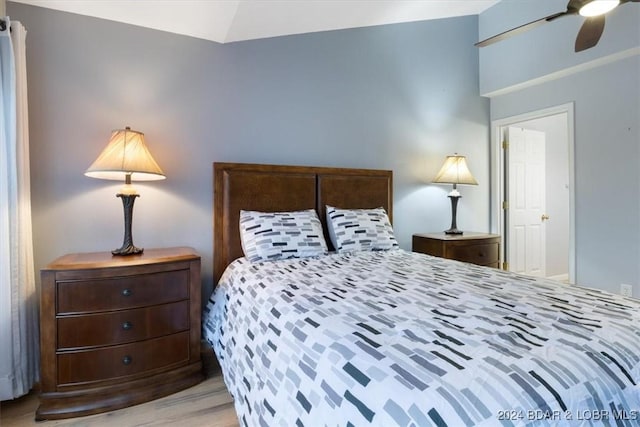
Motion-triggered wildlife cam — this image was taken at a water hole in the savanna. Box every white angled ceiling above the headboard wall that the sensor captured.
[10,0,499,43]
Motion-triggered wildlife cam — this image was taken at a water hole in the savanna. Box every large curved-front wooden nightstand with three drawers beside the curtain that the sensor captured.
[36,247,203,420]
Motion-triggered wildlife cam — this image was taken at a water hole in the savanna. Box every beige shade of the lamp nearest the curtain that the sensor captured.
[84,127,166,181]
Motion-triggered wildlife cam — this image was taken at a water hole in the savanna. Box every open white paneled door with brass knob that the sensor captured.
[505,127,548,277]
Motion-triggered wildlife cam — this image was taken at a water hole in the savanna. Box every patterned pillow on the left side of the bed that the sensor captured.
[240,209,328,262]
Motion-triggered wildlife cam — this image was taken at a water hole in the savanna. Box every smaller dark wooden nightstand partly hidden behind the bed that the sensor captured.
[412,232,500,268]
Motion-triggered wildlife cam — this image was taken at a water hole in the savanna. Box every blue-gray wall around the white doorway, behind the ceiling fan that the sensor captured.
[479,0,640,296]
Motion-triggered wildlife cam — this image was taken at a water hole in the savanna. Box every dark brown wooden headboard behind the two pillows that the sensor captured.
[213,162,393,284]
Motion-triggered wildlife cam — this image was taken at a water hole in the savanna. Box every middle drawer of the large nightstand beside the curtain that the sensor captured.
[57,300,189,349]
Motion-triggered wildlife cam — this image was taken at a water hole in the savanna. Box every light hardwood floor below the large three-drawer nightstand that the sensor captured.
[0,350,238,427]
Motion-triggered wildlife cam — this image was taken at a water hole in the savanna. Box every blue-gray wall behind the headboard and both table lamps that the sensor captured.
[7,2,489,300]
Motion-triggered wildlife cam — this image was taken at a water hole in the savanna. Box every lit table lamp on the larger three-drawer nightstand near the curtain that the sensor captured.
[84,127,166,255]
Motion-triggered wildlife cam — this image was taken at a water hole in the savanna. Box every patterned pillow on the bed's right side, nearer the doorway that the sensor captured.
[327,205,399,252]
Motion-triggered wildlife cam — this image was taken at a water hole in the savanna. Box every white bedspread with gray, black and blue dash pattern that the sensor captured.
[204,250,640,427]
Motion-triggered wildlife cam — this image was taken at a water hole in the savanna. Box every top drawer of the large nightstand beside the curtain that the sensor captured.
[57,270,189,313]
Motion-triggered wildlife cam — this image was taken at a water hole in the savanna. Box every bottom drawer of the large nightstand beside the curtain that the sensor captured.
[58,331,189,385]
